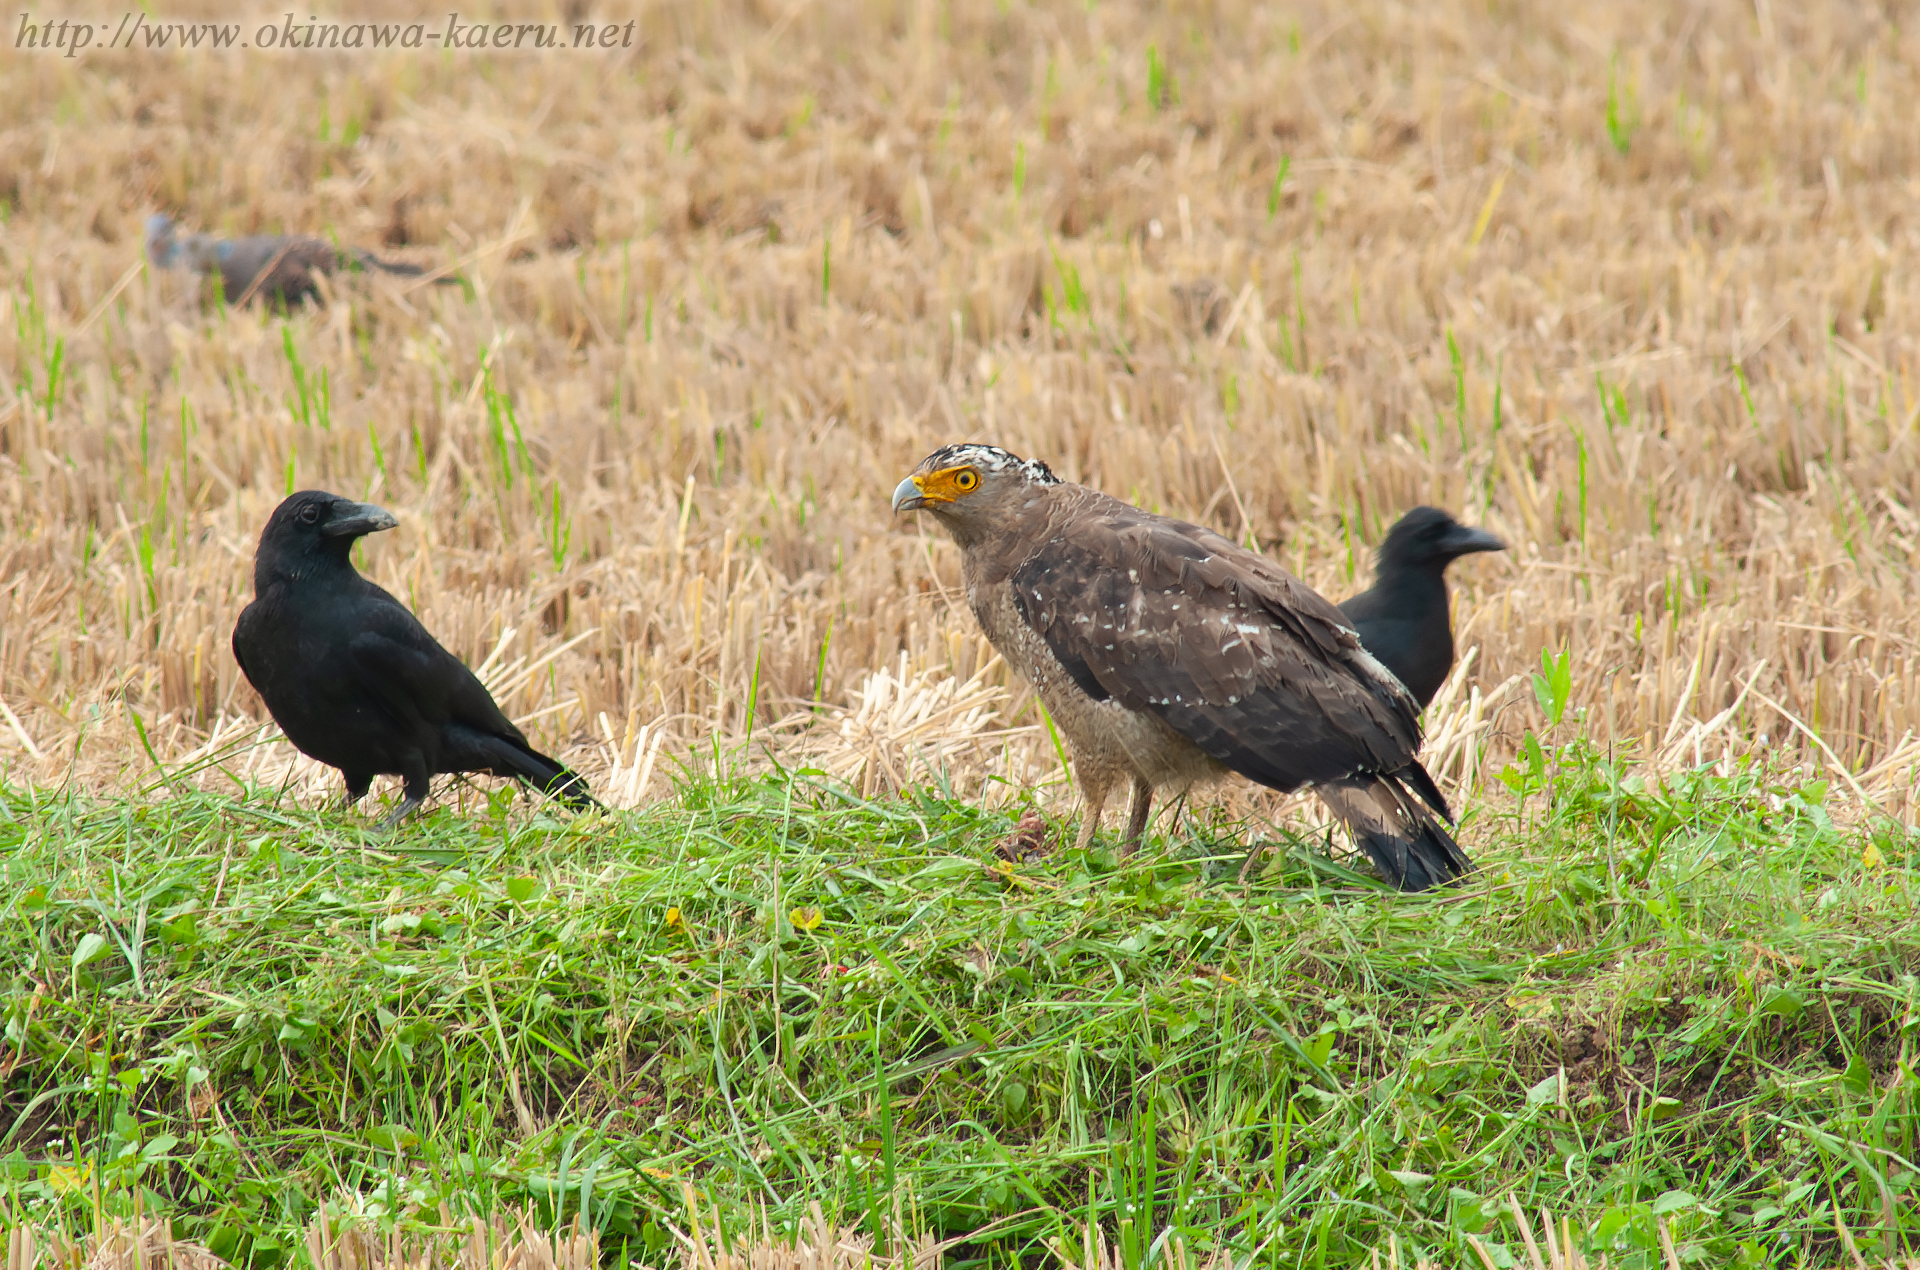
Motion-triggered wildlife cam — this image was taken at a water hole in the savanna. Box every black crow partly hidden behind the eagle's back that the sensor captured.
[1340,507,1507,709]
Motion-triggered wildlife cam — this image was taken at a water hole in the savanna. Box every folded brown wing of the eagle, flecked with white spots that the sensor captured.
[1010,503,1419,790]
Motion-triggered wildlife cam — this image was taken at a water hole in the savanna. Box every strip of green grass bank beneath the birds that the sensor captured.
[0,745,1920,1266]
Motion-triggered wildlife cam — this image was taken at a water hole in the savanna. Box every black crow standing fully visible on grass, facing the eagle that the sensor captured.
[234,490,599,822]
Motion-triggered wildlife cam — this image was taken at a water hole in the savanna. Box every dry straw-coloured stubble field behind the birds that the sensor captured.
[0,0,1920,818]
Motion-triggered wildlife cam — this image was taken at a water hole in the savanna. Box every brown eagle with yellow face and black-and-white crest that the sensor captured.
[893,444,1471,890]
